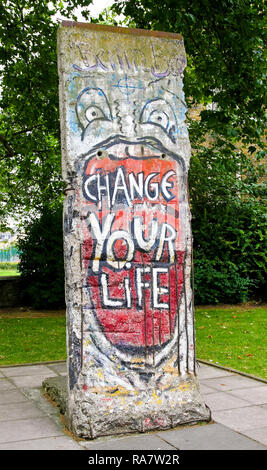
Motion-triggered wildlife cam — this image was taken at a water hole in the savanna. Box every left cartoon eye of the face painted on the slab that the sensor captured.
[76,87,112,140]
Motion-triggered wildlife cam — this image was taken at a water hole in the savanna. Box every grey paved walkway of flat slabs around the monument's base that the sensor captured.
[0,362,267,451]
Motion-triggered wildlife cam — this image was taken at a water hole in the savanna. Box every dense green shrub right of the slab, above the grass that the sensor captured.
[192,201,266,305]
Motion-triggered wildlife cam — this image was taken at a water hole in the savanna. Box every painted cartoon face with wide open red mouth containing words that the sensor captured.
[72,70,185,364]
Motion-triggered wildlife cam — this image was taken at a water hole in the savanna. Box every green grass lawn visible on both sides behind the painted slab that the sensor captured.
[0,305,267,379]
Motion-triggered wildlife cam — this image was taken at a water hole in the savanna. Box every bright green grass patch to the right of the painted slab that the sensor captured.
[195,306,267,379]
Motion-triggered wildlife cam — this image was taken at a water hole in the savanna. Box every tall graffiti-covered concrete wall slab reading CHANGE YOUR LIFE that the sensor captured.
[58,22,210,438]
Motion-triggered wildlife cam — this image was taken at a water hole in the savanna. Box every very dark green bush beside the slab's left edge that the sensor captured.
[18,206,64,309]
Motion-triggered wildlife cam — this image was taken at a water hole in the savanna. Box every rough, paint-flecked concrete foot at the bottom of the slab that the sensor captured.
[43,376,211,439]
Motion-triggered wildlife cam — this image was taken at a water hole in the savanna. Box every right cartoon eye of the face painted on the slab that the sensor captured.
[140,98,177,142]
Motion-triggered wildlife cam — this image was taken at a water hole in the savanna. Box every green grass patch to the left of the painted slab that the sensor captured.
[0,316,66,366]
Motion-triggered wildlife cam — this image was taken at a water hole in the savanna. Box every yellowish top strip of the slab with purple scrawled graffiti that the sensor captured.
[59,21,186,78]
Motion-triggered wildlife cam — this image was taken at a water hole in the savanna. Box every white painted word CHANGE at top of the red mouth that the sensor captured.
[83,167,175,208]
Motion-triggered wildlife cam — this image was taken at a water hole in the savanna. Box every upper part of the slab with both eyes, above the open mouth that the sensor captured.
[58,22,190,181]
